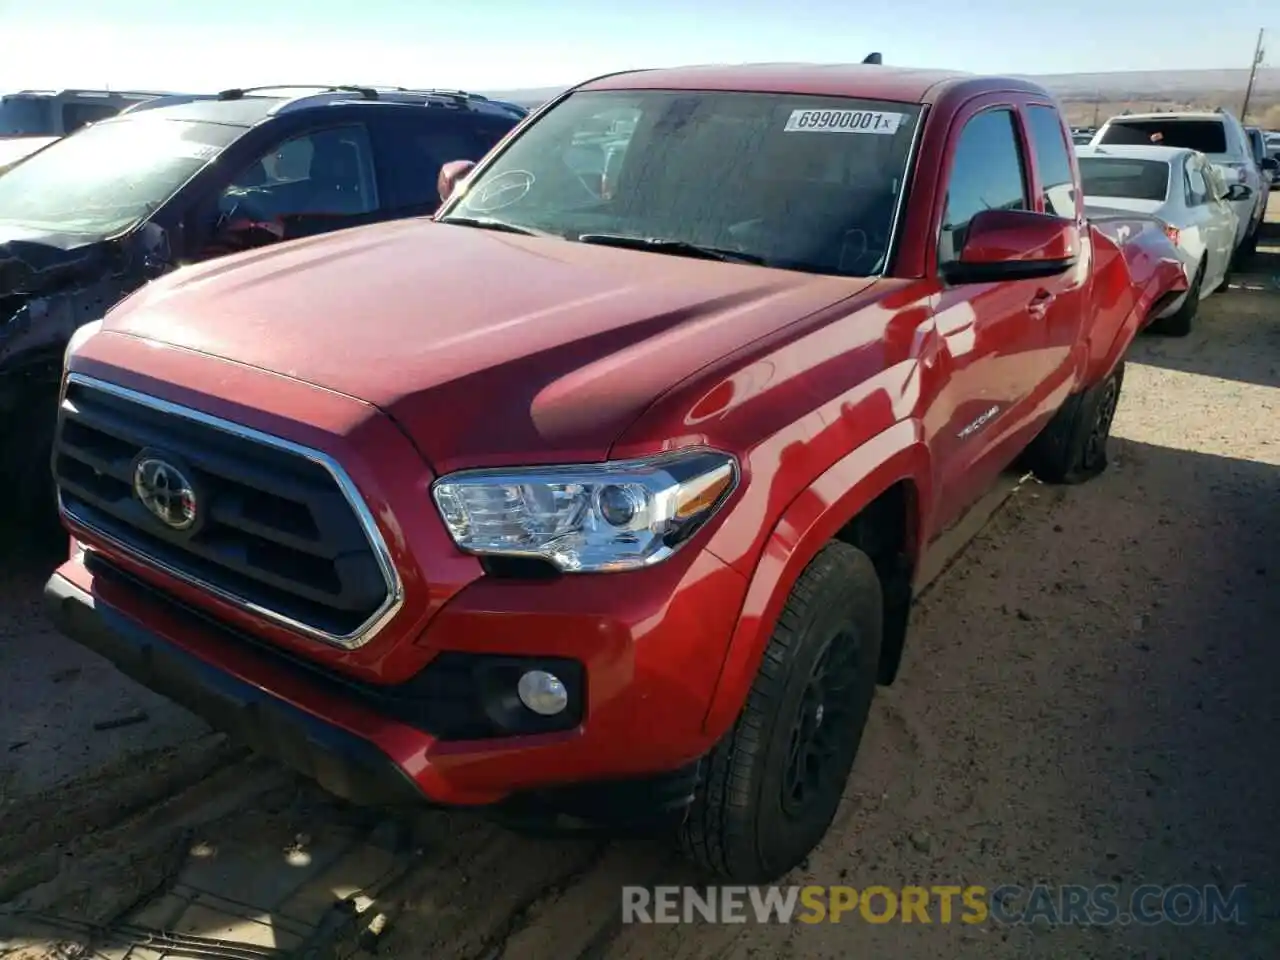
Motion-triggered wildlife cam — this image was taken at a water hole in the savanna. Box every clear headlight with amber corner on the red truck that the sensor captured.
[431,451,737,573]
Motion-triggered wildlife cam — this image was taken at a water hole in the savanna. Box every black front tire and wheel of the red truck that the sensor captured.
[680,543,884,883]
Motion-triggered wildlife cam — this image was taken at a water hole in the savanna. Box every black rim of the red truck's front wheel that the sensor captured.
[782,631,859,818]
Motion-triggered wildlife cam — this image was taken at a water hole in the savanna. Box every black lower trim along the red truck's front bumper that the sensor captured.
[45,573,699,828]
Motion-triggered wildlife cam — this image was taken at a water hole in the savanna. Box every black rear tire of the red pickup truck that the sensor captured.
[1025,361,1124,484]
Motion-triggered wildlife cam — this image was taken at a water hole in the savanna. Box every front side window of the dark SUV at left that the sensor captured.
[218,125,379,231]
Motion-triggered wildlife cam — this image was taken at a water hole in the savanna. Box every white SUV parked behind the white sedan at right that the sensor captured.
[1092,110,1270,255]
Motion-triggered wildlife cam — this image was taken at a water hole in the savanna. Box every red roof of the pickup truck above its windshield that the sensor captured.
[577,63,1048,104]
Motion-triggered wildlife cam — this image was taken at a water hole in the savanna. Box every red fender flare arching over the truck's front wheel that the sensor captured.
[703,420,933,740]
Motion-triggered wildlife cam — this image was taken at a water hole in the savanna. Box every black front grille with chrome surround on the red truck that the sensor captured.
[52,374,399,648]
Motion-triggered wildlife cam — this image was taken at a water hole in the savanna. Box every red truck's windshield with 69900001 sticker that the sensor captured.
[439,91,919,276]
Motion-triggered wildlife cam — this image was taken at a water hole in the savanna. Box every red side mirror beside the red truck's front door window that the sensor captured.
[943,210,1080,283]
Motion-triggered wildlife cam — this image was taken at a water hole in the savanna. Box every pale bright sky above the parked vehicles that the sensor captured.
[0,0,1280,92]
